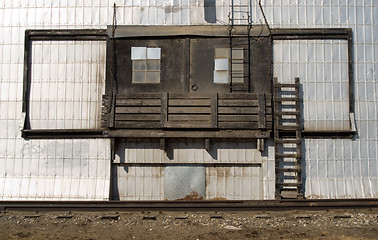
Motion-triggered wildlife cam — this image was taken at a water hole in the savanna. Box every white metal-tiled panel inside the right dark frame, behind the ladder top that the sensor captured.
[273,40,351,131]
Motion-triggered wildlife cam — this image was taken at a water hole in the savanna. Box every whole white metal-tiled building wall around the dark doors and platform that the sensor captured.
[0,0,378,200]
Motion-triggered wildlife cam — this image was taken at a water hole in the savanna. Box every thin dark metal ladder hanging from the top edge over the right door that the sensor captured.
[228,0,252,92]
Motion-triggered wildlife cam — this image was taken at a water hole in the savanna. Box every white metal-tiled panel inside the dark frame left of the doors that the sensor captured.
[29,41,106,129]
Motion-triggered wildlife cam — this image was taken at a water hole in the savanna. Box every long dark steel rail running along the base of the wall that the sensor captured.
[0,198,378,212]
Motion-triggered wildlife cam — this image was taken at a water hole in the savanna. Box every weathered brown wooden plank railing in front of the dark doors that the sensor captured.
[102,93,272,130]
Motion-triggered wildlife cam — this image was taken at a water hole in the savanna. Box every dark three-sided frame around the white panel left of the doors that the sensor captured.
[21,29,108,138]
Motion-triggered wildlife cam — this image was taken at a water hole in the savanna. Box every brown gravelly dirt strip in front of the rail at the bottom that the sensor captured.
[0,209,378,240]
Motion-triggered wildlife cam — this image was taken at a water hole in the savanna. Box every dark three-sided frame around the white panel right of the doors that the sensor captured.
[271,28,357,138]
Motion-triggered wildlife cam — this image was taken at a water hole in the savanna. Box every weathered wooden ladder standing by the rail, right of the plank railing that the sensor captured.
[273,78,303,199]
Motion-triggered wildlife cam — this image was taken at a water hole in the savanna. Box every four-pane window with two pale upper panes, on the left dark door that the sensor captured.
[131,47,161,83]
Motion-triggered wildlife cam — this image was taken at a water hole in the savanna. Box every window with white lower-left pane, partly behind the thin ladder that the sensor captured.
[214,48,244,83]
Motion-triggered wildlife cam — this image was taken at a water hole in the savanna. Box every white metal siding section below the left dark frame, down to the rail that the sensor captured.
[0,139,110,200]
